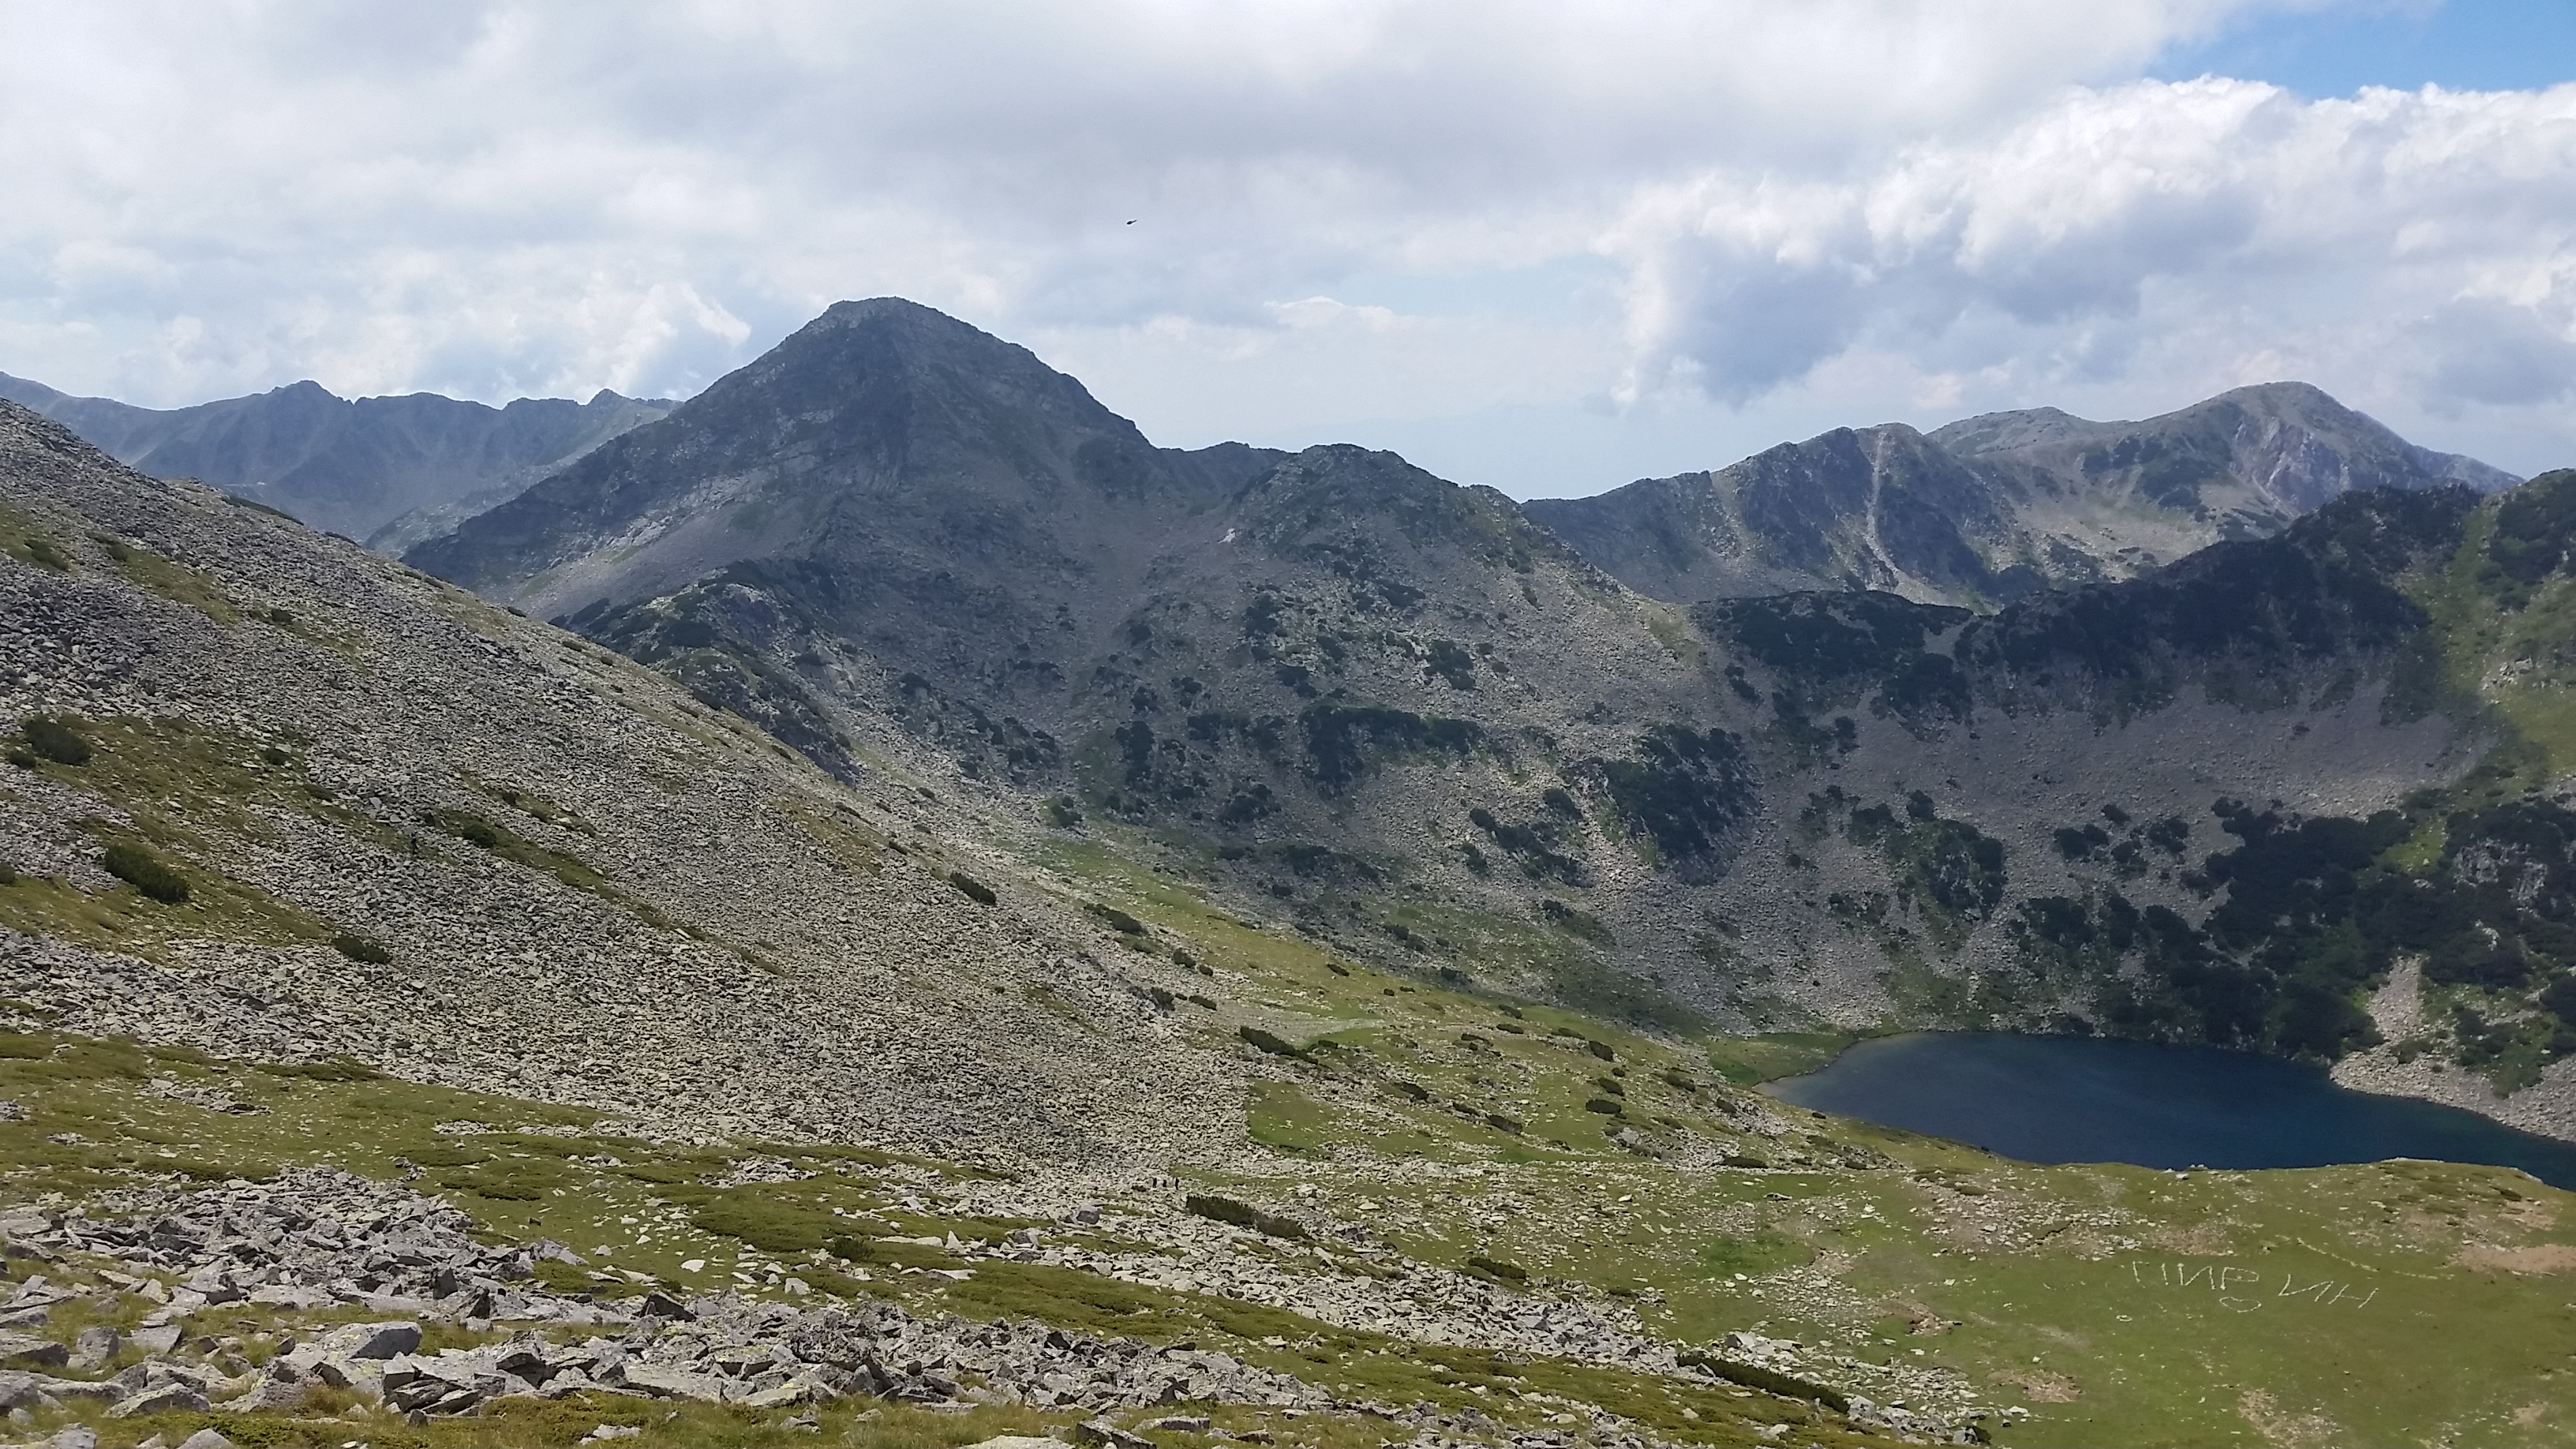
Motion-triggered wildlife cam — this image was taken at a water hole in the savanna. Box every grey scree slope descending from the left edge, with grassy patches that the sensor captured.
[0,407,1231,1158]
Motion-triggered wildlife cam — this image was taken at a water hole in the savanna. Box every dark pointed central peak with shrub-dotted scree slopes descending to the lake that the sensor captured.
[386,301,2576,1132]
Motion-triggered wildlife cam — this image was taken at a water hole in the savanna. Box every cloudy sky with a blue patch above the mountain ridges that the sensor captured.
[0,0,2576,498]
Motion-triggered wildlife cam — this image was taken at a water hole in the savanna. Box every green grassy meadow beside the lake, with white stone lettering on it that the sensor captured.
[973,835,2576,1443]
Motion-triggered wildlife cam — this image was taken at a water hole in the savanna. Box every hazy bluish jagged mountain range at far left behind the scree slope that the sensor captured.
[0,374,672,552]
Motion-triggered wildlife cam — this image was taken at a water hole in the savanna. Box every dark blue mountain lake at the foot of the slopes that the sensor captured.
[1765,1032,2576,1191]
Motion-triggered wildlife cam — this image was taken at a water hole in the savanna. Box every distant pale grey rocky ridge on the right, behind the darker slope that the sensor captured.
[1528,382,2517,608]
